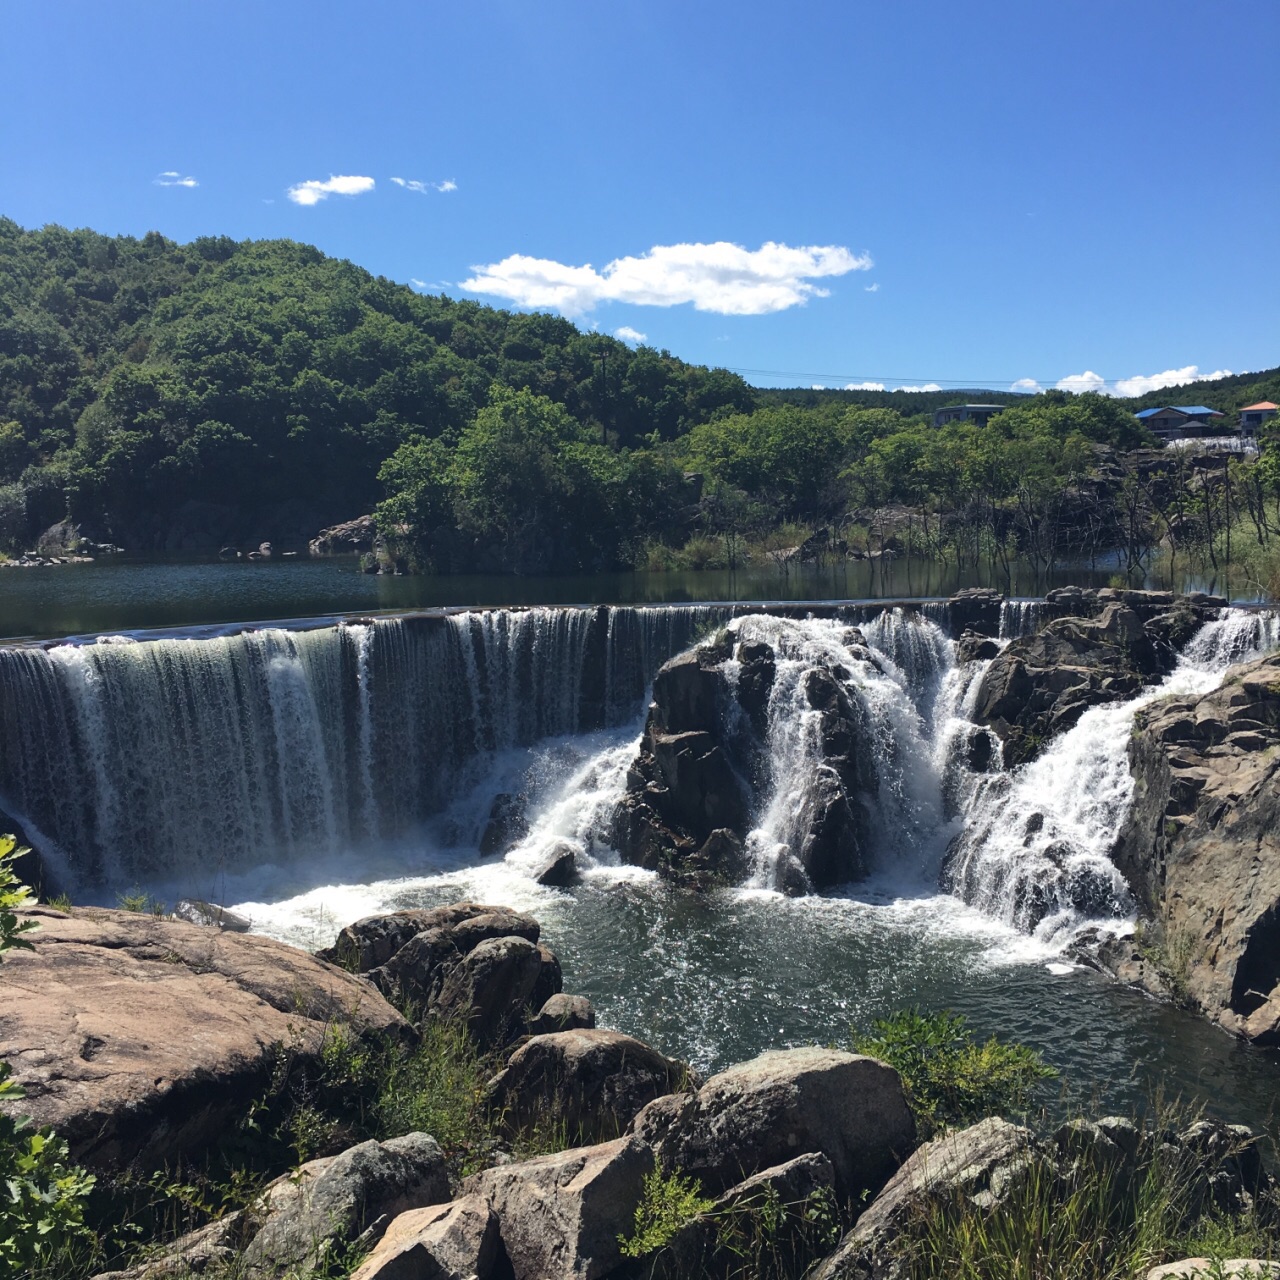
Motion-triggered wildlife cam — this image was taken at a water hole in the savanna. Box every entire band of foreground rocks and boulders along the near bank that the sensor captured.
[0,904,1272,1280]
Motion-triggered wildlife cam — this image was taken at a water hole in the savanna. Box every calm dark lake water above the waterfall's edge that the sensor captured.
[0,557,1253,640]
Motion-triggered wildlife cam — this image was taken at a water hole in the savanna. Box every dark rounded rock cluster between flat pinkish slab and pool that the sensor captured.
[320,902,563,1047]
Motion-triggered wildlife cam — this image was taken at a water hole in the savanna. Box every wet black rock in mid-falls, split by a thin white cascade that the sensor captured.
[612,628,876,893]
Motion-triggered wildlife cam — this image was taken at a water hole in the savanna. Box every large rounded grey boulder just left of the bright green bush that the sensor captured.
[634,1048,915,1199]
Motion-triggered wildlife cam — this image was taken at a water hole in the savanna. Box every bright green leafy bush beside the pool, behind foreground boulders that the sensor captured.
[854,1007,1057,1134]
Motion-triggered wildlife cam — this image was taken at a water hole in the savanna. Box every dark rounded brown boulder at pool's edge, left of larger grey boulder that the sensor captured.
[486,1029,692,1143]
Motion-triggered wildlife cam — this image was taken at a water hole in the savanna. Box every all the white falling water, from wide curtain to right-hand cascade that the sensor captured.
[0,588,1280,962]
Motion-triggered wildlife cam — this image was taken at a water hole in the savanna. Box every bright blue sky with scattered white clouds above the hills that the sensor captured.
[0,0,1280,393]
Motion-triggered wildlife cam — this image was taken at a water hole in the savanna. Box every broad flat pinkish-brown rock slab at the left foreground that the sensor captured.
[0,908,411,1167]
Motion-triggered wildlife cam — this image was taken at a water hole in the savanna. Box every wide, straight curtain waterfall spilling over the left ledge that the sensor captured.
[0,607,727,890]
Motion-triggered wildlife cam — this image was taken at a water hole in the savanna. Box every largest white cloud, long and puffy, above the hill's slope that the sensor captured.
[462,241,872,316]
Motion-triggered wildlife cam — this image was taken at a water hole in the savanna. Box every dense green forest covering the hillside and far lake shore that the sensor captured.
[0,220,1280,572]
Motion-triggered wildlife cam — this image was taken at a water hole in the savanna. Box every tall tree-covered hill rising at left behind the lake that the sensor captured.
[0,220,754,545]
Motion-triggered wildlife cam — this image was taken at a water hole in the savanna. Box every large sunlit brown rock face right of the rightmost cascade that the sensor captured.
[1112,655,1280,1044]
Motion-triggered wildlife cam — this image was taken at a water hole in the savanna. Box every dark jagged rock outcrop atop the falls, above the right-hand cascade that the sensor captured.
[974,603,1172,765]
